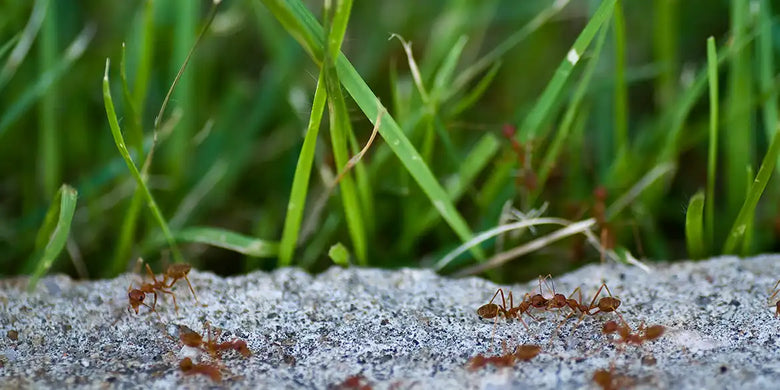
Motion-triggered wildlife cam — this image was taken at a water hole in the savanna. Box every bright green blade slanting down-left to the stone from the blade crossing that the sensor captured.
[279,72,327,267]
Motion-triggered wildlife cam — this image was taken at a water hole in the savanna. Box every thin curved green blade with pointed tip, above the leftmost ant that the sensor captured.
[103,58,184,263]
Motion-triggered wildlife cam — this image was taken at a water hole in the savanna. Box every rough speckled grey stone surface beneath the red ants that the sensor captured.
[0,256,780,389]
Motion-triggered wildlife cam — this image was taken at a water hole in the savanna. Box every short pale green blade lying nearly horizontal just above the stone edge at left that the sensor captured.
[173,226,279,257]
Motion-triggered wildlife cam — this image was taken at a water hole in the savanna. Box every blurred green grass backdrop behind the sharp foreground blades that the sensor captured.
[0,0,780,280]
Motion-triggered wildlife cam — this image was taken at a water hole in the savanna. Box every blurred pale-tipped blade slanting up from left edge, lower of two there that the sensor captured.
[0,24,96,137]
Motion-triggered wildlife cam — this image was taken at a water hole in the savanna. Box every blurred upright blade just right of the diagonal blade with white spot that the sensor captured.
[616,0,628,155]
